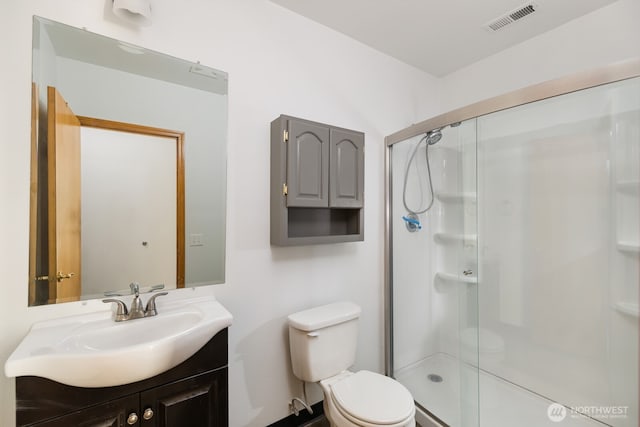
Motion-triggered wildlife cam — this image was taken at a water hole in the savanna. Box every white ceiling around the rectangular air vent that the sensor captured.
[271,0,616,77]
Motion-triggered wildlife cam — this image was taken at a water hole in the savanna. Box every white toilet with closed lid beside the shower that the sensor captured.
[289,302,415,427]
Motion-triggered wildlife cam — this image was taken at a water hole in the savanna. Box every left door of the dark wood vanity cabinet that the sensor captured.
[31,393,140,427]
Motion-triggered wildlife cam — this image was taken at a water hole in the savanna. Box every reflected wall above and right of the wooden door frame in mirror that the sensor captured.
[57,58,228,289]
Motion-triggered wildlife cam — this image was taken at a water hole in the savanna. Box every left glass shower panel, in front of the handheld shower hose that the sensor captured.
[389,120,479,427]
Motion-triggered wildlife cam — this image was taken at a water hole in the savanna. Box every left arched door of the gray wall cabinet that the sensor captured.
[287,120,329,207]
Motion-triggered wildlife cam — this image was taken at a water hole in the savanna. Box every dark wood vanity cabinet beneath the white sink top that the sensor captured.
[16,329,229,427]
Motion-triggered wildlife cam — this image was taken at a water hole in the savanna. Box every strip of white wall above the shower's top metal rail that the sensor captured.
[442,0,640,111]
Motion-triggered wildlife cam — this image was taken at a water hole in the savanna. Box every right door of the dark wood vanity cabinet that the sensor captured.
[140,368,228,427]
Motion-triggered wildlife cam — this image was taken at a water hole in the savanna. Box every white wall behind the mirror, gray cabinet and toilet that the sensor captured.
[0,0,438,427]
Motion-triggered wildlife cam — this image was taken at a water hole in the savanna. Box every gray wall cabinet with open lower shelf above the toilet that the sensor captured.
[271,115,364,246]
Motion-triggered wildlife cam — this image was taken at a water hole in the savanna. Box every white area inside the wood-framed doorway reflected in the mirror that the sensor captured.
[80,127,178,298]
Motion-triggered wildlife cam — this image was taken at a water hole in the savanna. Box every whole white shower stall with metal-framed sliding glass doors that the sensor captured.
[385,61,640,427]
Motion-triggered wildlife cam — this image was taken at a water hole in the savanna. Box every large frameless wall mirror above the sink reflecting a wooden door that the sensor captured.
[28,17,228,305]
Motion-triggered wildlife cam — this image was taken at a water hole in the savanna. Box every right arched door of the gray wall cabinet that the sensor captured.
[329,129,364,208]
